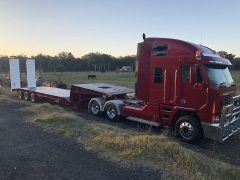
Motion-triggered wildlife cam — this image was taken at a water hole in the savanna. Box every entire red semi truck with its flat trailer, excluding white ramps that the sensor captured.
[12,38,240,143]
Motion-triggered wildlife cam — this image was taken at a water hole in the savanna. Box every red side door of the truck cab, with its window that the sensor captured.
[180,64,207,109]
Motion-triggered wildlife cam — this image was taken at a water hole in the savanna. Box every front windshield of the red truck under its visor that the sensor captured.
[206,65,234,86]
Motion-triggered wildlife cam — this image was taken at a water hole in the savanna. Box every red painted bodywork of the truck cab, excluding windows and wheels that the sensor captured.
[123,38,235,126]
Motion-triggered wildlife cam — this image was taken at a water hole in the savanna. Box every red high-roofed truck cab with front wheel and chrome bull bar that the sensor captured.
[123,38,240,143]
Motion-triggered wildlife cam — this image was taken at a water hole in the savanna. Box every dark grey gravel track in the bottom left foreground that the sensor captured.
[0,99,162,180]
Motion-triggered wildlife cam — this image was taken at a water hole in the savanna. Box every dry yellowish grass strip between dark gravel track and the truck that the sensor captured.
[19,103,240,179]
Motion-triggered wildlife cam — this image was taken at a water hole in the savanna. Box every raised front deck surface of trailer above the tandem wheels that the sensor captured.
[74,83,135,95]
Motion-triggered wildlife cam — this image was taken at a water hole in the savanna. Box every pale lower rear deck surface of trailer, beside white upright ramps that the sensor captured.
[22,87,70,98]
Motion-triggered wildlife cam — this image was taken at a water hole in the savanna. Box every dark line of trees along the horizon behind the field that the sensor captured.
[0,51,240,73]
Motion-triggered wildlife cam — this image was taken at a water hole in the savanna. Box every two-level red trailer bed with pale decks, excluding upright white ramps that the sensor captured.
[14,83,134,108]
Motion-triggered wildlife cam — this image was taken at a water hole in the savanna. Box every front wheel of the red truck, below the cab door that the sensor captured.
[175,116,202,143]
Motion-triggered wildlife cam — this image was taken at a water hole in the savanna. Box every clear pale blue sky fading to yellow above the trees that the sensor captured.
[0,0,240,57]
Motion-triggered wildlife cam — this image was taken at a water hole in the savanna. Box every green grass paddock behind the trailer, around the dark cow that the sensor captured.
[42,71,240,94]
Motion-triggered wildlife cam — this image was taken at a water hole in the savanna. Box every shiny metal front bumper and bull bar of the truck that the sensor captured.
[202,96,240,142]
